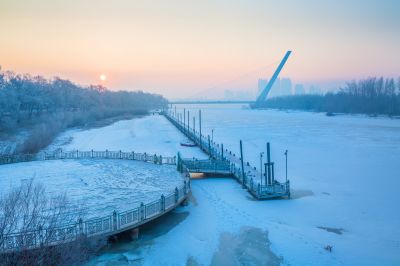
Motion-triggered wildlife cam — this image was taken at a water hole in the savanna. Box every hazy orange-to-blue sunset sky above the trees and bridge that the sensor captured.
[0,0,400,98]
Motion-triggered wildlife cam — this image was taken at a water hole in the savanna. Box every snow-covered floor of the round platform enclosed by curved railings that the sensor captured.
[0,159,183,219]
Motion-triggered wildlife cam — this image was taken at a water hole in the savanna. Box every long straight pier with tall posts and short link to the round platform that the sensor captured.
[162,109,290,200]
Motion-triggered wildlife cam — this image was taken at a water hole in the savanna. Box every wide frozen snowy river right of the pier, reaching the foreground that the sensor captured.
[92,105,400,265]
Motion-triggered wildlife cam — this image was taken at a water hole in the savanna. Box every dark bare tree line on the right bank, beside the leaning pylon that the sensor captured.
[259,77,400,116]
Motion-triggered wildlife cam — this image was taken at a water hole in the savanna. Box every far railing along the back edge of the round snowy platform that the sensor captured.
[0,149,176,165]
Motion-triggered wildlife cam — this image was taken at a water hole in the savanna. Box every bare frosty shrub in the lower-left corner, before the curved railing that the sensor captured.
[0,179,106,265]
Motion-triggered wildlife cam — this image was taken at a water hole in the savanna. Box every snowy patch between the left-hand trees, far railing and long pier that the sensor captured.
[47,115,207,158]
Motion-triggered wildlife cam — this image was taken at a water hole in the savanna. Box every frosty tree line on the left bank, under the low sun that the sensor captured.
[0,71,168,153]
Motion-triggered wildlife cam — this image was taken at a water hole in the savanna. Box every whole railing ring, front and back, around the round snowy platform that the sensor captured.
[0,150,190,253]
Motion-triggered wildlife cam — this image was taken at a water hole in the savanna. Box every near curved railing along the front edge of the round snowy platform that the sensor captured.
[0,178,190,253]
